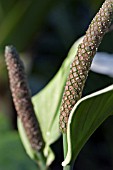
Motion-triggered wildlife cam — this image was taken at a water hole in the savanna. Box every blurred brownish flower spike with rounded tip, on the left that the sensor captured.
[5,46,44,151]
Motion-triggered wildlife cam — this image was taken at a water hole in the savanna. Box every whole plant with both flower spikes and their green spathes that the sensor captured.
[5,0,113,170]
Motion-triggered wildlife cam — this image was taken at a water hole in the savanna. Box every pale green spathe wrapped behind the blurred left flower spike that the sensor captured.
[18,38,82,164]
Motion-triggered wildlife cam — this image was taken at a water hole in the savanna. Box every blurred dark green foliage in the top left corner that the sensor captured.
[0,0,59,50]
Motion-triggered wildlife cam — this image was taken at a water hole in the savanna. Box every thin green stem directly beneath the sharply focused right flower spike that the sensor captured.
[63,134,73,170]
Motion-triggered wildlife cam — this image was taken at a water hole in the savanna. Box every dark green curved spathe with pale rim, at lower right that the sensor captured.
[62,85,113,166]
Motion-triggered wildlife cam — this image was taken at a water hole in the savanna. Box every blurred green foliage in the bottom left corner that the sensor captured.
[0,113,37,170]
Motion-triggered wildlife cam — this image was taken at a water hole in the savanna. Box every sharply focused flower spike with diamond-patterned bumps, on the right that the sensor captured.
[59,0,113,133]
